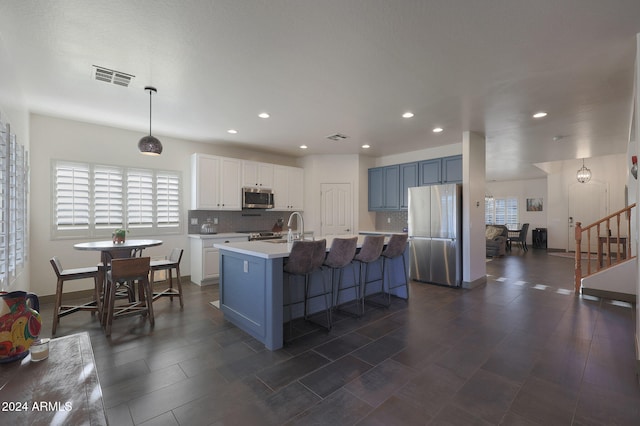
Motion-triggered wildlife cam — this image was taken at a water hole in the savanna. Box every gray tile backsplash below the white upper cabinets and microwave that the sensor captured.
[187,210,291,234]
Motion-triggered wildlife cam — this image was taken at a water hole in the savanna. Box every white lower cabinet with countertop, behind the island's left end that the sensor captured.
[190,234,248,285]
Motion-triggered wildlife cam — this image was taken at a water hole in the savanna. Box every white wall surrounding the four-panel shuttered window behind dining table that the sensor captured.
[30,114,298,295]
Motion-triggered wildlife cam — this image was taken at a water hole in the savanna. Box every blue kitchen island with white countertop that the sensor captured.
[214,235,409,350]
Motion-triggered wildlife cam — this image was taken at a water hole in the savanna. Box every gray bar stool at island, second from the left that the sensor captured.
[323,237,362,316]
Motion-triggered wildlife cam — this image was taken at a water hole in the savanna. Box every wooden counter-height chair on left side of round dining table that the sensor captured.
[49,256,102,335]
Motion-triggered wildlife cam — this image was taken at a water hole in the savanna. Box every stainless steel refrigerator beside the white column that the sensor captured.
[408,184,462,287]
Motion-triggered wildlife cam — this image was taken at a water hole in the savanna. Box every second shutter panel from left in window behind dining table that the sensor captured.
[93,166,124,229]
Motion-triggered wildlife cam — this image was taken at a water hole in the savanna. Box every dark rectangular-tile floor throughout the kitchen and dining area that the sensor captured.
[37,250,640,426]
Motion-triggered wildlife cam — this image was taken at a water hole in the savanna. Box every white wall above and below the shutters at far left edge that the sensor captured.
[0,37,31,290]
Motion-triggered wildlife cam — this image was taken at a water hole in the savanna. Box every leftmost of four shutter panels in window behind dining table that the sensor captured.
[54,163,90,230]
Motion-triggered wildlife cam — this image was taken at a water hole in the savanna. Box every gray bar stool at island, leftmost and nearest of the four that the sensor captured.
[283,239,332,338]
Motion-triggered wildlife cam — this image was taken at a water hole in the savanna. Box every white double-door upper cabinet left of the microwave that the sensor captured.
[191,154,242,210]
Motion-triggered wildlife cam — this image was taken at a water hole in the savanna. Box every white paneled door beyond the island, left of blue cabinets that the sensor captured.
[320,183,353,235]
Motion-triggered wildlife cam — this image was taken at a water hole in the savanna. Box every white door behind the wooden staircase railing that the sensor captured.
[568,181,609,251]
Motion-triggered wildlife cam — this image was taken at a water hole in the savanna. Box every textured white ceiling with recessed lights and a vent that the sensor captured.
[0,0,640,180]
